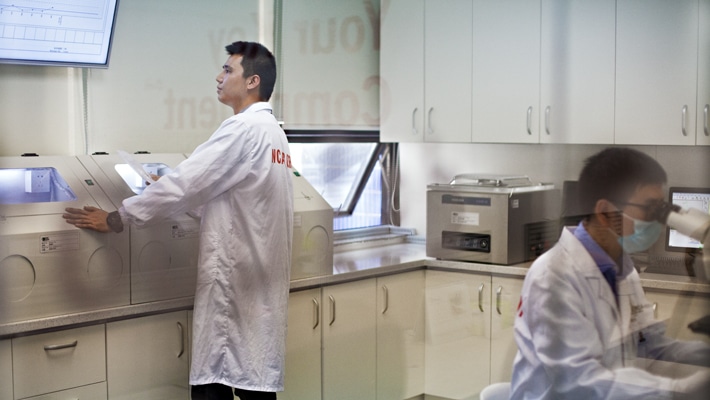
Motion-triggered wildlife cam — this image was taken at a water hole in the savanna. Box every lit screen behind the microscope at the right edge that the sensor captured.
[666,187,710,252]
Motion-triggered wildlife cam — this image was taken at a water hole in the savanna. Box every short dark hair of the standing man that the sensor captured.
[225,41,276,101]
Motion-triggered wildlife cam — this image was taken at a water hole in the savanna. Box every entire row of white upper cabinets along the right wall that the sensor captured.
[380,0,710,145]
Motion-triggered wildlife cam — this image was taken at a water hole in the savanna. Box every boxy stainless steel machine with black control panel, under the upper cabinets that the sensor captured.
[426,174,560,265]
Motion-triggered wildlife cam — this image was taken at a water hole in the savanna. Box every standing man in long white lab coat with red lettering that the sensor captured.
[64,42,293,400]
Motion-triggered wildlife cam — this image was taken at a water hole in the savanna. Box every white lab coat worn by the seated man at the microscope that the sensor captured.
[511,228,710,400]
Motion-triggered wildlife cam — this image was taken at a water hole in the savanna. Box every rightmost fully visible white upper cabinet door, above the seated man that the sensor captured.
[615,0,698,145]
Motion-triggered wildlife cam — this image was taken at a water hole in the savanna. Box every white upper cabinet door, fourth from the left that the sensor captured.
[540,0,616,143]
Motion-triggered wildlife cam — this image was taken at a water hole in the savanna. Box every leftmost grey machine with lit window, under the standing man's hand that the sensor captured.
[0,156,130,323]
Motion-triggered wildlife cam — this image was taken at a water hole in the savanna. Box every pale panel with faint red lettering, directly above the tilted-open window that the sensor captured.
[276,0,380,129]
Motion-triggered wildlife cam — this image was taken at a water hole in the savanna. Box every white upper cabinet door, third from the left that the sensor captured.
[472,0,540,143]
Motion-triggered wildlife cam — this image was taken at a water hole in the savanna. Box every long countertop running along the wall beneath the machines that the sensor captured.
[0,242,710,339]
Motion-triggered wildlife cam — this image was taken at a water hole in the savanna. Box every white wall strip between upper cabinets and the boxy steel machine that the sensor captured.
[400,143,710,236]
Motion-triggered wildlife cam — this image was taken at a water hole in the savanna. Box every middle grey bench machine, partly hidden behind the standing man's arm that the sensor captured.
[78,153,200,304]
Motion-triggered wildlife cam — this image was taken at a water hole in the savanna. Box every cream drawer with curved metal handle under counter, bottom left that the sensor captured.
[12,325,106,399]
